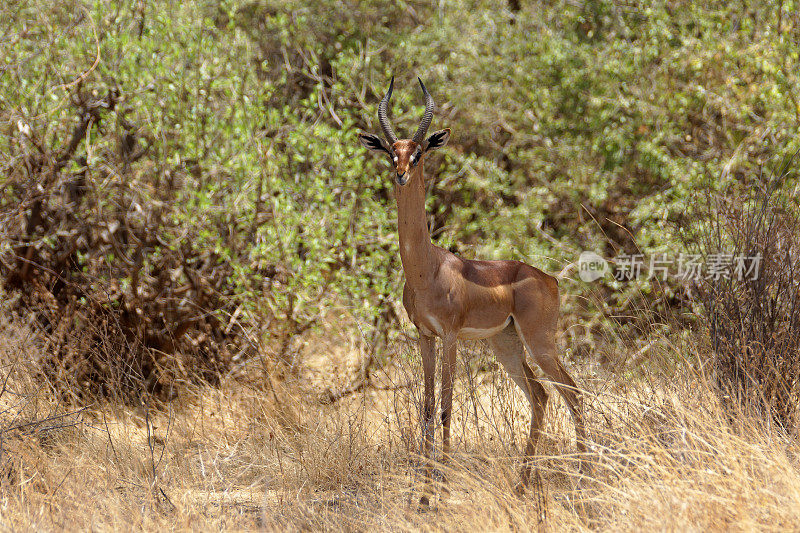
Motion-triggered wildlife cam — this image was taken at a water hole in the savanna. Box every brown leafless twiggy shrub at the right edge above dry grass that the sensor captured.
[699,157,800,429]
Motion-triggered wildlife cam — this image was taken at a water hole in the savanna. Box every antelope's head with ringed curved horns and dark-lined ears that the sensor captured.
[358,76,450,186]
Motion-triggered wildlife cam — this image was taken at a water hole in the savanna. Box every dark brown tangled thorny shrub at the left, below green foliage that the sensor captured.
[0,85,247,399]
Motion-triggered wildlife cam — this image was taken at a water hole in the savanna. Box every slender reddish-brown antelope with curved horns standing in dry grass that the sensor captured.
[358,77,586,500]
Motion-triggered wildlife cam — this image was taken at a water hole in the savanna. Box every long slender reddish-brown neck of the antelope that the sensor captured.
[395,161,437,288]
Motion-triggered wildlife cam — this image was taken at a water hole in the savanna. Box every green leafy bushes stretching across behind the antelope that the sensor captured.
[0,0,800,386]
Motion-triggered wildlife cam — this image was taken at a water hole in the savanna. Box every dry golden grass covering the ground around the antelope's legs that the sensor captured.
[0,312,800,531]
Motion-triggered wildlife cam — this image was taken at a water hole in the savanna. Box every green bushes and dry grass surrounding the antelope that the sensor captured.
[0,0,800,530]
